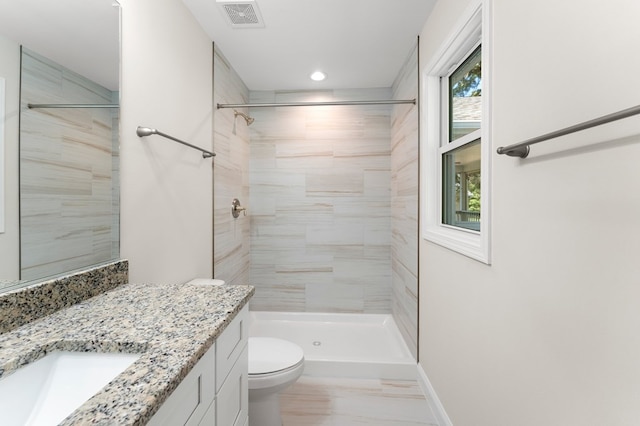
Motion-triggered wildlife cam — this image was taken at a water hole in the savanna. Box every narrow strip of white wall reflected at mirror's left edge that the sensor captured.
[0,36,20,281]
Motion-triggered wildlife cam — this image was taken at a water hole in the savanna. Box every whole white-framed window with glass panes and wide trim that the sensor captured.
[421,0,491,263]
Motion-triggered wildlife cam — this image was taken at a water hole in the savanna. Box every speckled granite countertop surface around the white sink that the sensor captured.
[0,284,254,425]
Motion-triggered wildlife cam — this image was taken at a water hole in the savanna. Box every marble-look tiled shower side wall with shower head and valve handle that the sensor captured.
[213,46,254,285]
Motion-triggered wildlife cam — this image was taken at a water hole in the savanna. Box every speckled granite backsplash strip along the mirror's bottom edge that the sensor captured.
[0,260,129,333]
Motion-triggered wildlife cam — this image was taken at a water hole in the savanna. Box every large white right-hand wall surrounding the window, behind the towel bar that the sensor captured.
[419,0,640,426]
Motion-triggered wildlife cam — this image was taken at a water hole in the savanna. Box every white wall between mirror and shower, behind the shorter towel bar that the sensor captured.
[121,0,215,283]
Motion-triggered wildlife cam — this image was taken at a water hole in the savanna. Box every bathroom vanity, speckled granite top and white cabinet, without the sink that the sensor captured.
[0,284,254,426]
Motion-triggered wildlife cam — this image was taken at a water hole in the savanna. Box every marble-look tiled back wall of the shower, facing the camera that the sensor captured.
[250,89,392,313]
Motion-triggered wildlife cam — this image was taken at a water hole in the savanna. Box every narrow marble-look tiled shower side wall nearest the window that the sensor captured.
[391,48,419,357]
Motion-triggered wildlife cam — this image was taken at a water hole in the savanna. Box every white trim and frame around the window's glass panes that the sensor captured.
[420,0,491,264]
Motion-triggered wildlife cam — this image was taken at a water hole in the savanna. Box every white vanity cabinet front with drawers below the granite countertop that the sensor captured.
[148,306,249,426]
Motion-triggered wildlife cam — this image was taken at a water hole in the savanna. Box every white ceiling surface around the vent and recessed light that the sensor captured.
[183,0,436,90]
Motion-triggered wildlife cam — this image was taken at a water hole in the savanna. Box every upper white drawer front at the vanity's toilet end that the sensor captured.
[216,305,249,391]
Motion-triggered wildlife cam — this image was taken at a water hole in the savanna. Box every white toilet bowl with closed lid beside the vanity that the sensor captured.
[248,337,304,426]
